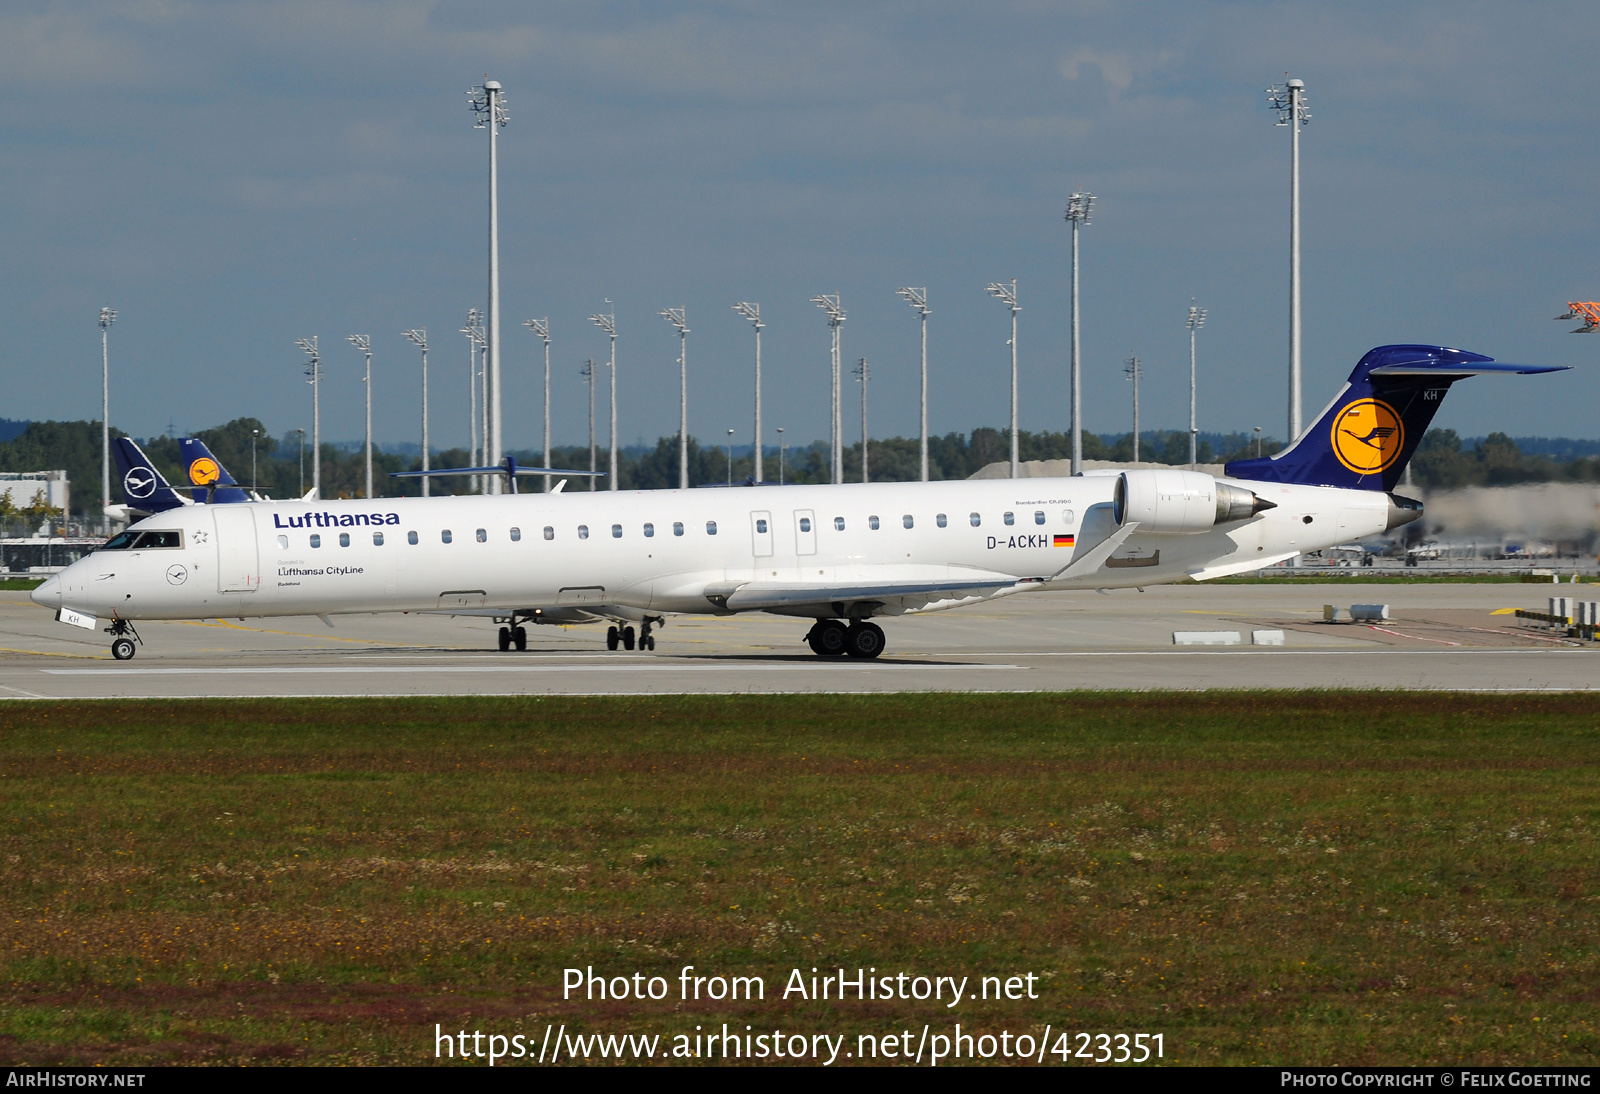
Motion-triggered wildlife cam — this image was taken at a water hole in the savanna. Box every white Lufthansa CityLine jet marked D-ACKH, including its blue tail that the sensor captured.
[32,345,1558,661]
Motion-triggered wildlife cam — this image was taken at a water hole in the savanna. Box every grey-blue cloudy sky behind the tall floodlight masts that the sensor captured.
[0,0,1600,446]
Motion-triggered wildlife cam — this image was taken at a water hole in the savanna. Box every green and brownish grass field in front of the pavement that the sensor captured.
[0,693,1600,1065]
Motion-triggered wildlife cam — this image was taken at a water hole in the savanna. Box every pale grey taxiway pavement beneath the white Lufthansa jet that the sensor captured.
[0,581,1600,699]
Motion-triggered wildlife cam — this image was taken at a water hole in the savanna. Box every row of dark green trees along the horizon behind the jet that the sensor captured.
[0,417,1600,526]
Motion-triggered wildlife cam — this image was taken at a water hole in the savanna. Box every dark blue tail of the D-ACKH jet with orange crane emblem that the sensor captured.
[1222,345,1565,491]
